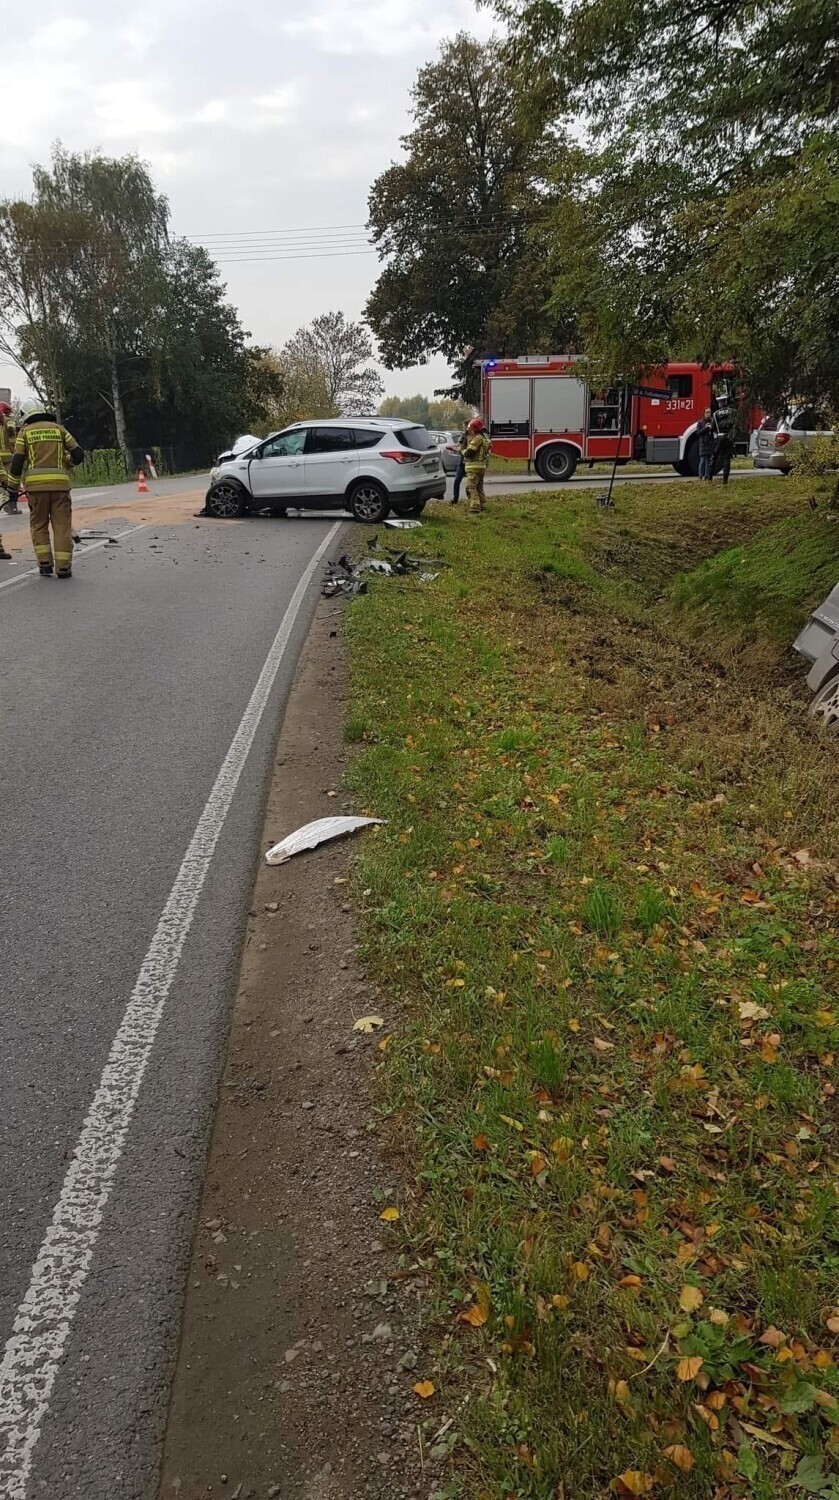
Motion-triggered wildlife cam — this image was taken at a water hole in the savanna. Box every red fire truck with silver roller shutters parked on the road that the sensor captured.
[480,354,756,480]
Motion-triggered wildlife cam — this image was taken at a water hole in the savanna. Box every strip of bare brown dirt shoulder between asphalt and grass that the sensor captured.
[159,603,432,1500]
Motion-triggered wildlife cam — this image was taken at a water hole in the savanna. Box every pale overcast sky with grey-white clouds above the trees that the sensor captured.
[0,0,491,395]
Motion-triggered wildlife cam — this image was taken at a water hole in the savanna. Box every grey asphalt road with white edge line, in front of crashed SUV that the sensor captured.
[0,510,345,1500]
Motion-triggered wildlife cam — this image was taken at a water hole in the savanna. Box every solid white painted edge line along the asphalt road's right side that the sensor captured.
[0,521,342,1500]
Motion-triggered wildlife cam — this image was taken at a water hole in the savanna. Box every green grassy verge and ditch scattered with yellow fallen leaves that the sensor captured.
[347,480,839,1500]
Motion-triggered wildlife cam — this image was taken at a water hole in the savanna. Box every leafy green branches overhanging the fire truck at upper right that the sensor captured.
[495,0,839,410]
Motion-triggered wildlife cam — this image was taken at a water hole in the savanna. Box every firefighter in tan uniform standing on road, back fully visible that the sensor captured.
[9,402,84,578]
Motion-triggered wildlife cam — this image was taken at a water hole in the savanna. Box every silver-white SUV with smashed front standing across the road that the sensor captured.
[206,417,446,525]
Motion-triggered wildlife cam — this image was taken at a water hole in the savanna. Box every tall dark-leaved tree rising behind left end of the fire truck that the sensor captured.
[366,33,572,398]
